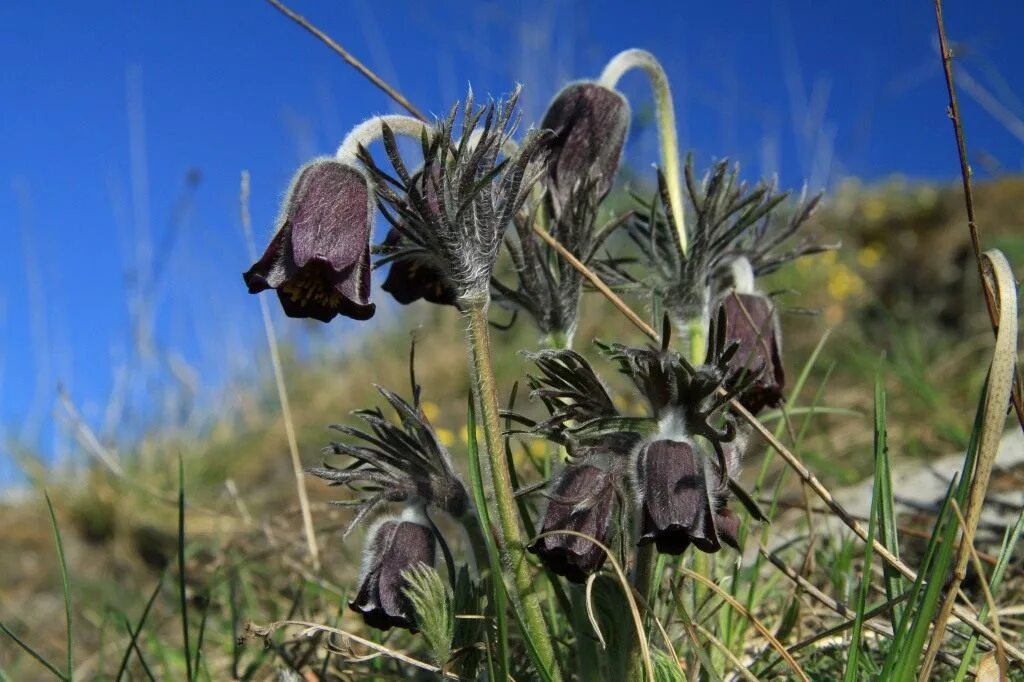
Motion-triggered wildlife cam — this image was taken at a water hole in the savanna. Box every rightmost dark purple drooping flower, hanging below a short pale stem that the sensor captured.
[719,291,785,415]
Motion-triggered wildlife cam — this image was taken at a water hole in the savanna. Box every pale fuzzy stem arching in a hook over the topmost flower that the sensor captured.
[600,49,686,253]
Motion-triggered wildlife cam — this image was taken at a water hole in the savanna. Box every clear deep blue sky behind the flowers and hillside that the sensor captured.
[0,0,1024,481]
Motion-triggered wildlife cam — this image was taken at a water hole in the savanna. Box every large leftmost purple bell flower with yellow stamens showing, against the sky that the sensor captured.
[243,159,376,323]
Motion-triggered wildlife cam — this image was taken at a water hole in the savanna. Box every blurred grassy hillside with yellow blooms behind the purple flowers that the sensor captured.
[0,177,1024,679]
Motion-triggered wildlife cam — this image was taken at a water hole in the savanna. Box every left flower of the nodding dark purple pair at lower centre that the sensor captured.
[527,464,615,583]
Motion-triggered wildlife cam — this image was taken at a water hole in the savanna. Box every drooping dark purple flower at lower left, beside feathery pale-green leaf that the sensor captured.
[348,512,436,632]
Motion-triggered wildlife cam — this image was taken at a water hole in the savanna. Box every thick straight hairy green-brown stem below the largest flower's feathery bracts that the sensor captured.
[463,299,560,680]
